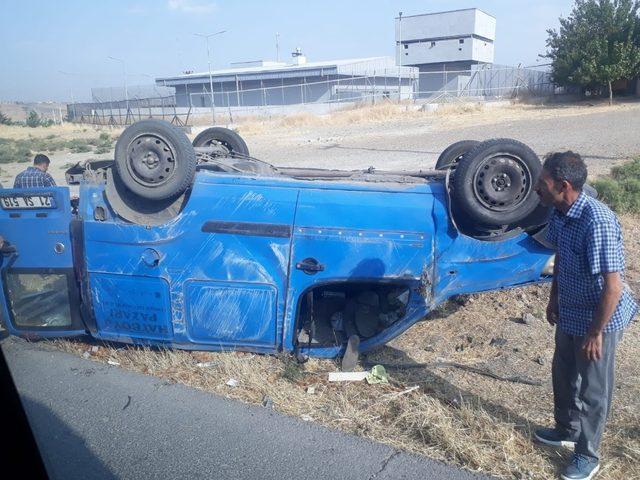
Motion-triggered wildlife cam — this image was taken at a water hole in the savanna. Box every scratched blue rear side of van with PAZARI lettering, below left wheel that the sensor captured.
[85,178,297,351]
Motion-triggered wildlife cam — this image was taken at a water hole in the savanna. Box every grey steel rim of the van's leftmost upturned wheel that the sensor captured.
[127,133,177,187]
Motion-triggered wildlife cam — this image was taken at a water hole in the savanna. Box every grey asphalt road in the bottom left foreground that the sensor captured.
[2,338,489,480]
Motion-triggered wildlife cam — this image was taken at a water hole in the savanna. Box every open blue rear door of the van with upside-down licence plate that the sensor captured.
[0,187,85,337]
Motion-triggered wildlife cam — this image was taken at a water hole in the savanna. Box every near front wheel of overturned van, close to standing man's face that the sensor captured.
[451,138,542,226]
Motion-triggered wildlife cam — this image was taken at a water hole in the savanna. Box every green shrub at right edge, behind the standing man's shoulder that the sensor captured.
[593,158,640,213]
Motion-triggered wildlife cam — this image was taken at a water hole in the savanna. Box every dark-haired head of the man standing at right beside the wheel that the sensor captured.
[536,150,587,211]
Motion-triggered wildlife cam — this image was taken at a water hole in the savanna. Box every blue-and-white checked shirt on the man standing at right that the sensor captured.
[547,192,638,336]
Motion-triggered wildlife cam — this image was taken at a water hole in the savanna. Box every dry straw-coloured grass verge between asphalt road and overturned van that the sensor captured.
[48,216,640,480]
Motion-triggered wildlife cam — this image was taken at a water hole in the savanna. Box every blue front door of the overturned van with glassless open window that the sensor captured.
[285,184,433,356]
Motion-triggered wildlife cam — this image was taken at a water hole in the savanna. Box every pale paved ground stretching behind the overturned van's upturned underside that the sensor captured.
[247,103,640,174]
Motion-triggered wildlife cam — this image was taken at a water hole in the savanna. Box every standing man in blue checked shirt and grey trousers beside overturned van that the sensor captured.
[535,151,638,480]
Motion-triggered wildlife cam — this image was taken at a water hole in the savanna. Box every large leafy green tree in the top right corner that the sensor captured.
[543,0,640,104]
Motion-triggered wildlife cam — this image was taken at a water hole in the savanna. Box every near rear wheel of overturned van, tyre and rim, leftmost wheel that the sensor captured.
[115,120,197,200]
